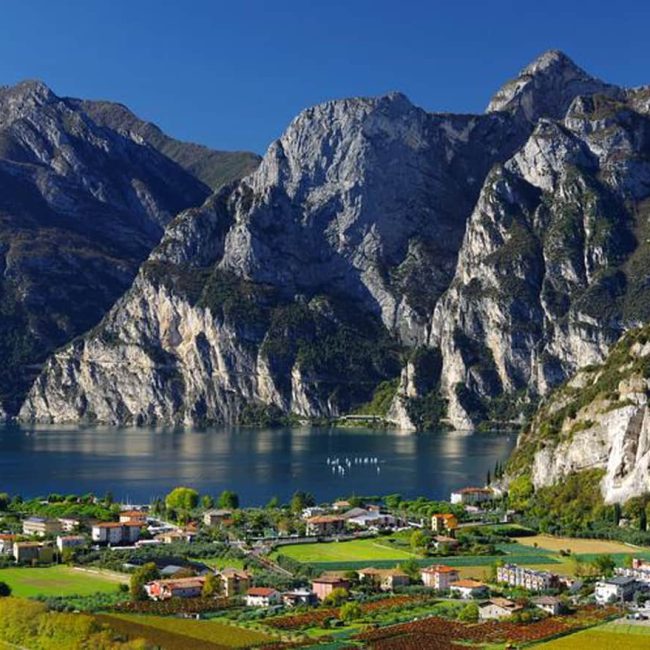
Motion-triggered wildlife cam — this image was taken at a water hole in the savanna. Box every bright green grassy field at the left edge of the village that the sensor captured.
[0,565,119,598]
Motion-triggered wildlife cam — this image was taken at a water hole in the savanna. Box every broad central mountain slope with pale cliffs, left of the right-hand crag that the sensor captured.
[21,94,526,422]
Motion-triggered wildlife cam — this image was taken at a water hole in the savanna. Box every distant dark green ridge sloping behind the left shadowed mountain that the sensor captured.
[66,99,261,190]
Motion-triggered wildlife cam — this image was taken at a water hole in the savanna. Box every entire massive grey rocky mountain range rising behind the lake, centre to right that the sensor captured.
[21,51,650,429]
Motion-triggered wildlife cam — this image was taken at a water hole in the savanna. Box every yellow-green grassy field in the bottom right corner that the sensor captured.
[535,622,650,650]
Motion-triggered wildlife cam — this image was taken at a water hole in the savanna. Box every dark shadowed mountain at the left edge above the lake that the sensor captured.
[0,81,256,414]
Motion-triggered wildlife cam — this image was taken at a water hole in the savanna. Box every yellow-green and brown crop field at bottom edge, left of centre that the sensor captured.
[97,614,274,650]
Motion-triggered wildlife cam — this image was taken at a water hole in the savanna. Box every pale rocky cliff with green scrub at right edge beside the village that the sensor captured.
[509,326,650,503]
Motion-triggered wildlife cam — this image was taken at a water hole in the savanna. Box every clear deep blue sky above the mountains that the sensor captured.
[0,0,650,153]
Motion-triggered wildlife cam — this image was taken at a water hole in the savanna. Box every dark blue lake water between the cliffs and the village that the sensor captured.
[0,425,516,505]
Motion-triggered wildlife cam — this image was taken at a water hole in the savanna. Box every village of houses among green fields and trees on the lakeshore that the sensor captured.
[0,480,650,647]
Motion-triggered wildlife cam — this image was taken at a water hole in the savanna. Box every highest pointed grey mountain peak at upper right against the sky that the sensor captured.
[487,50,621,122]
